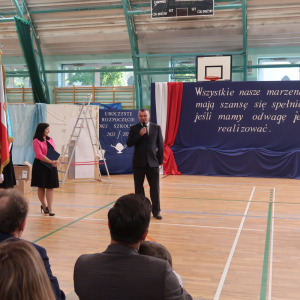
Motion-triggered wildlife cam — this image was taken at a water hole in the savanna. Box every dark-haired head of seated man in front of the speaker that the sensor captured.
[108,194,151,245]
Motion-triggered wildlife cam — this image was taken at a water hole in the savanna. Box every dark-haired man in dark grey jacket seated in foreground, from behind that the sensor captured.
[74,194,192,300]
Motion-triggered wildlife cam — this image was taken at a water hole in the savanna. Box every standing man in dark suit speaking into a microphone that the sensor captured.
[126,108,164,220]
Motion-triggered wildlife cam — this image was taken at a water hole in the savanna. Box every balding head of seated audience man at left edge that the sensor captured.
[0,189,28,237]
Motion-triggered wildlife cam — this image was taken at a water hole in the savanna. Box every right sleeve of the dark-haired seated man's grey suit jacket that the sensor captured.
[164,262,193,300]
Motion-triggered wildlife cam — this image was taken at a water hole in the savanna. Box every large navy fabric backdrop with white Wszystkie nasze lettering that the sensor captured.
[151,81,300,178]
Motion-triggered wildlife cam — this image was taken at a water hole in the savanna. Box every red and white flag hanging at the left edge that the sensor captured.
[0,65,10,174]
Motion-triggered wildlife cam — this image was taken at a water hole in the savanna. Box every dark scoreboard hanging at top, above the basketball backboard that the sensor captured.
[151,0,214,18]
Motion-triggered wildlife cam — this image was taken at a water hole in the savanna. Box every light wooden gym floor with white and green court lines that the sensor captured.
[22,175,300,300]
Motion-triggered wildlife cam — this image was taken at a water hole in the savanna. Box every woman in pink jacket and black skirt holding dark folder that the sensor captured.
[31,123,59,216]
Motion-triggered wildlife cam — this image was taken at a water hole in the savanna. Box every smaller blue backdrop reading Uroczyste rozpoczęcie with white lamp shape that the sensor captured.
[99,109,139,174]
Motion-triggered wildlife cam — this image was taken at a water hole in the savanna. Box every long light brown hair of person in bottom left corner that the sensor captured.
[0,238,55,300]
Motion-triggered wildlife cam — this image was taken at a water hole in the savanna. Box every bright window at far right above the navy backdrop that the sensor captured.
[258,57,300,81]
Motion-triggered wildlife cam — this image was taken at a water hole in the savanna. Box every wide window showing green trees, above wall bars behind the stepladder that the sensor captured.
[62,63,133,86]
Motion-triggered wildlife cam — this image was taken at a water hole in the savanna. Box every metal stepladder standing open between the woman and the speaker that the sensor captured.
[58,94,111,187]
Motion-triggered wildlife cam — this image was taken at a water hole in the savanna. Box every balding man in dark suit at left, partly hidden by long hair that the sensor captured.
[0,189,66,300]
